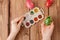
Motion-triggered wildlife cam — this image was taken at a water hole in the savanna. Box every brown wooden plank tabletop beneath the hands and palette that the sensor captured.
[0,0,60,40]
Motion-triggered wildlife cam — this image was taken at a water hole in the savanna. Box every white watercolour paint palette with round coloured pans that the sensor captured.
[23,7,44,28]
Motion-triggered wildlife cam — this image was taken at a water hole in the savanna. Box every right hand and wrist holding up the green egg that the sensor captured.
[41,22,54,40]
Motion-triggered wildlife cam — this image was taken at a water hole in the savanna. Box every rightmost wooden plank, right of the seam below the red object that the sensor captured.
[49,0,60,40]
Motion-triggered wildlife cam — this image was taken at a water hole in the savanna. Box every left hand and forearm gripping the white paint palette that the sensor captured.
[7,16,24,40]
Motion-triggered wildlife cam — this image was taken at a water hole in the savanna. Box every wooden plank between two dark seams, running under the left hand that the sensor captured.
[10,0,29,40]
